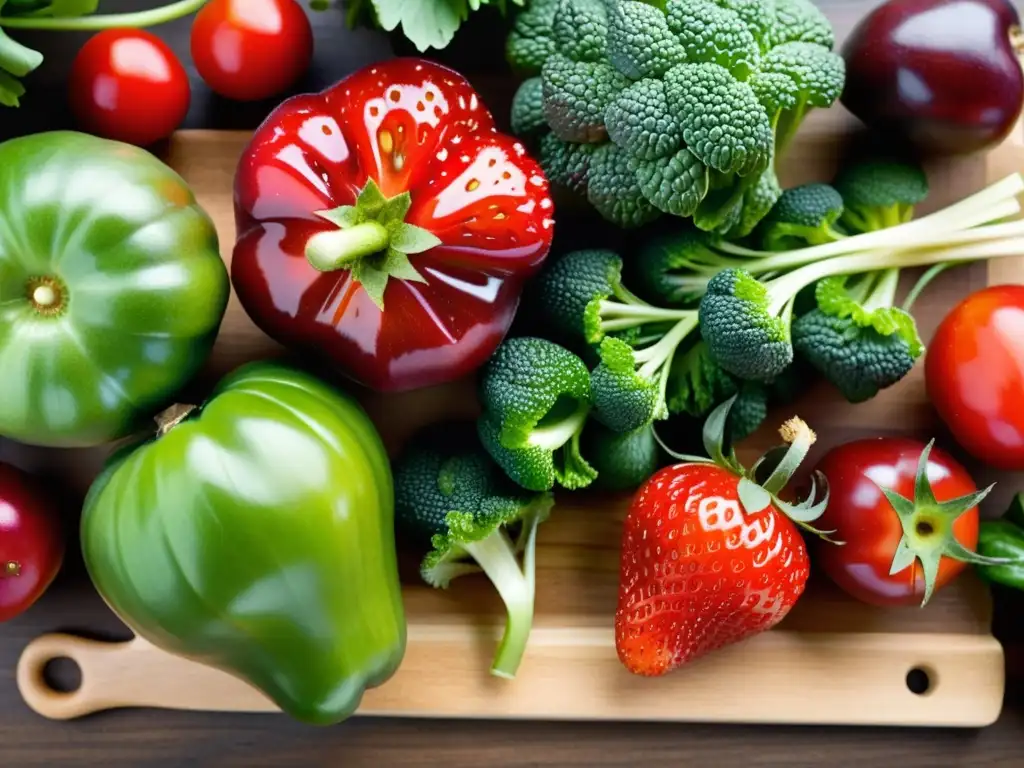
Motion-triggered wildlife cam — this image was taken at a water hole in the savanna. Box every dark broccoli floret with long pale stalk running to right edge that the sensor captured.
[698,221,1024,381]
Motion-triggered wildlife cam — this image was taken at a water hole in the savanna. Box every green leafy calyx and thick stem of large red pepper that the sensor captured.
[305,179,441,310]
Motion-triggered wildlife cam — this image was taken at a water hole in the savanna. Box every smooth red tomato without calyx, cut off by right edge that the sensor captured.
[925,286,1024,470]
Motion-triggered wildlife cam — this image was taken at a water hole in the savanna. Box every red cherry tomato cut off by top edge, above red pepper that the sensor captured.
[191,0,313,101]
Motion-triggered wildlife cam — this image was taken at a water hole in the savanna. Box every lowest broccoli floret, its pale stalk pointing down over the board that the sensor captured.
[393,424,554,678]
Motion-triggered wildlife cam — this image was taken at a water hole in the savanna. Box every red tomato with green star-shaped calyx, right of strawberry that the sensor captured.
[814,437,978,605]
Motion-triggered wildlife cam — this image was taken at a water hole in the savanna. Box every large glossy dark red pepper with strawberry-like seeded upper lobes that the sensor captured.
[231,58,554,391]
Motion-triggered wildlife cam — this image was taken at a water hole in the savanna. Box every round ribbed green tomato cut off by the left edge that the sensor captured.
[0,131,230,447]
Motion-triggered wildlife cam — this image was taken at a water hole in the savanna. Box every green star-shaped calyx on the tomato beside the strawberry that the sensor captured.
[879,440,1014,607]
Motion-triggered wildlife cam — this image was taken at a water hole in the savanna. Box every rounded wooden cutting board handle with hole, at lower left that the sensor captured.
[17,633,135,720]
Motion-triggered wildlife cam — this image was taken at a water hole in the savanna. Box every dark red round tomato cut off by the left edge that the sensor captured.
[0,464,65,622]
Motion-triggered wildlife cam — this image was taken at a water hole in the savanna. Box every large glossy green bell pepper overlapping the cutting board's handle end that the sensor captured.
[81,361,406,724]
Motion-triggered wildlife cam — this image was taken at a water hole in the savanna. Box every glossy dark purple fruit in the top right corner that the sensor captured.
[841,0,1024,155]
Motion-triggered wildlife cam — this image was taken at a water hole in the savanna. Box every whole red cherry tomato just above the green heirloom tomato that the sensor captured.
[69,30,191,146]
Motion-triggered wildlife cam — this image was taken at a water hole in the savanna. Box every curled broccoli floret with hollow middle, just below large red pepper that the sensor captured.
[477,337,597,490]
